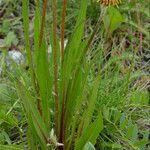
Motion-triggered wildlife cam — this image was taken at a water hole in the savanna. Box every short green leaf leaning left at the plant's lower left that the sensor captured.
[17,82,48,147]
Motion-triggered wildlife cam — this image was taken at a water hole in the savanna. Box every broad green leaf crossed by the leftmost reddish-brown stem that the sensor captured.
[33,1,52,131]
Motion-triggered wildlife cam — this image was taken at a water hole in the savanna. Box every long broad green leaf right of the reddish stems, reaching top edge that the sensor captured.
[59,0,88,138]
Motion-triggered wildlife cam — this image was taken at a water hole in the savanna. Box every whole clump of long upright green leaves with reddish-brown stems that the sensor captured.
[3,0,103,150]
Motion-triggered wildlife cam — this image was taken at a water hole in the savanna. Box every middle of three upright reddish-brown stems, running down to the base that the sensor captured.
[52,0,58,136]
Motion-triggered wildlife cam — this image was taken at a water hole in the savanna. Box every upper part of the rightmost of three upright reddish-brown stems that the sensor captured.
[61,0,67,62]
